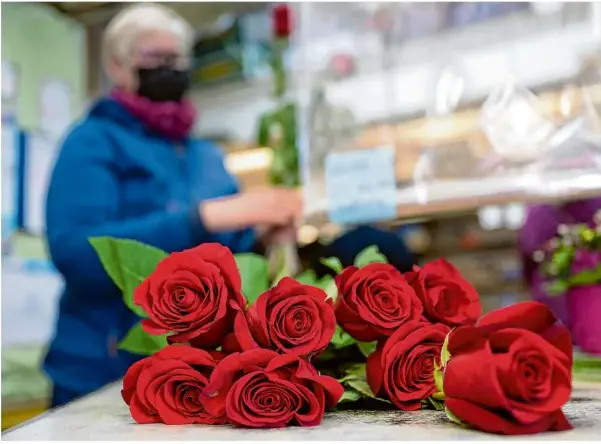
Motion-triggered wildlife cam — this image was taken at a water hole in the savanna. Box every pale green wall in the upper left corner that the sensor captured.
[2,3,86,129]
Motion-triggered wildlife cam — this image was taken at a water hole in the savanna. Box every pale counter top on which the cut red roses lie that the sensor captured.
[2,383,601,441]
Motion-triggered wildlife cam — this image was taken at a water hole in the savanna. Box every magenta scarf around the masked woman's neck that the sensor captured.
[111,89,196,140]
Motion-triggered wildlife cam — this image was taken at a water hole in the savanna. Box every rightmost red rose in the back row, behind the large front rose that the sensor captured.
[405,259,482,327]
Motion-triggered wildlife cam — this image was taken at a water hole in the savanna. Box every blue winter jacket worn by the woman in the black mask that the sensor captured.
[44,99,255,395]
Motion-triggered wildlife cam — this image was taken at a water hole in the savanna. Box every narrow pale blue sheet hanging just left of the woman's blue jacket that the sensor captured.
[25,132,58,235]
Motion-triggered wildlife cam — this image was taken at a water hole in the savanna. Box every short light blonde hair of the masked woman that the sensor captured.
[102,3,194,64]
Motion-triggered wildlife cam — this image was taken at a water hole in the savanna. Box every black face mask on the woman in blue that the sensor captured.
[138,66,190,102]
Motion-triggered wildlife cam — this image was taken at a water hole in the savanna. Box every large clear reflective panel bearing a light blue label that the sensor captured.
[291,2,601,224]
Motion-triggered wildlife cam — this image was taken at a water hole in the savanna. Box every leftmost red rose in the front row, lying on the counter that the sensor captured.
[121,345,225,425]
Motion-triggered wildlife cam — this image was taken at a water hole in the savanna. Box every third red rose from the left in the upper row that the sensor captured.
[335,263,422,342]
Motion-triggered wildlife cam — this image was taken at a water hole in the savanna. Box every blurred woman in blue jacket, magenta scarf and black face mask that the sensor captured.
[44,4,302,406]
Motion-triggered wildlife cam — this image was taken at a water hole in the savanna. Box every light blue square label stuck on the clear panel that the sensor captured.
[325,146,397,224]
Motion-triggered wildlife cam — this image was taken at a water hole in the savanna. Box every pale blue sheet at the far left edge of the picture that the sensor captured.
[2,112,18,240]
